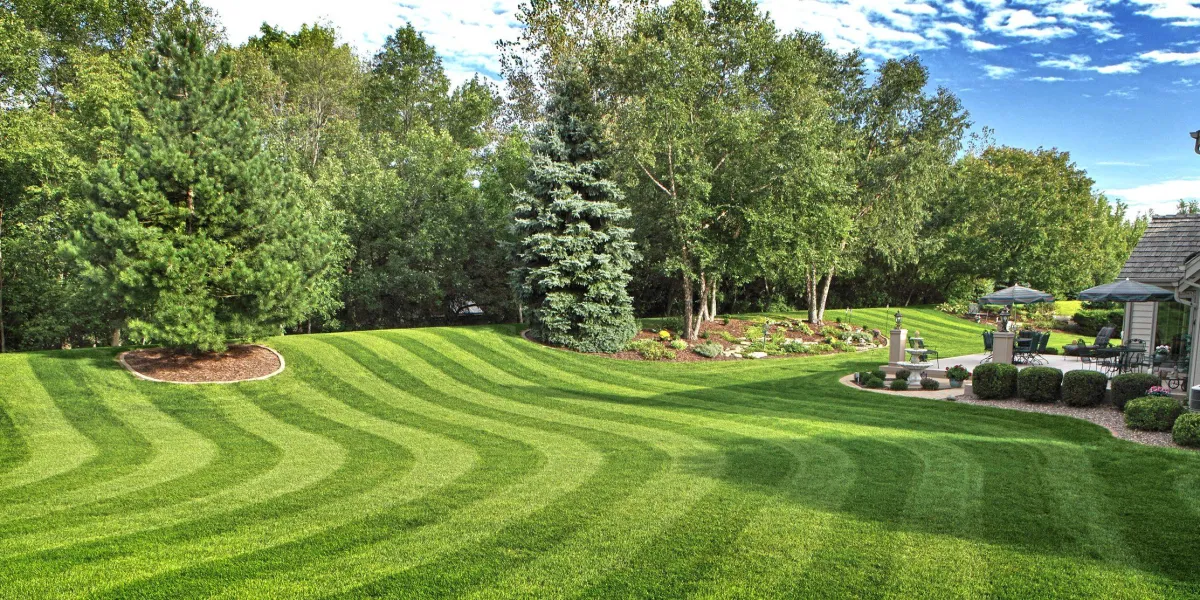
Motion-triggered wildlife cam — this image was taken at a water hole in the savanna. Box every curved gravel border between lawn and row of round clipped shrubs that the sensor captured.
[839,373,1196,451]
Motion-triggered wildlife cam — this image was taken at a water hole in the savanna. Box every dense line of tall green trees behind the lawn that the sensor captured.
[0,0,1145,349]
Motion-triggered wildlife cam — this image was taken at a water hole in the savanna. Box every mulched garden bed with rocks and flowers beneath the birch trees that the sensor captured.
[601,318,887,362]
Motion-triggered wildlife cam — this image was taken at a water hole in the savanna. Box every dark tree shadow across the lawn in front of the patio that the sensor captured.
[573,374,1200,586]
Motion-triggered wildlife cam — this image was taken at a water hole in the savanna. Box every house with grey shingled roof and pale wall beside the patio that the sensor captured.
[1120,215,1200,385]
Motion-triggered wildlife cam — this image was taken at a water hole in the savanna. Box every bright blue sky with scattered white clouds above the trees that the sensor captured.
[209,0,1200,214]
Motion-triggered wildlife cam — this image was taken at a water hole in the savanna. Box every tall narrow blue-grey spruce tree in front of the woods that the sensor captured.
[514,71,638,352]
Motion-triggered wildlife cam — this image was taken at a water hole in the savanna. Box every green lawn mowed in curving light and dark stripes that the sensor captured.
[0,310,1200,599]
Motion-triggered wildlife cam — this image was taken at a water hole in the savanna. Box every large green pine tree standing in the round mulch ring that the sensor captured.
[68,26,341,350]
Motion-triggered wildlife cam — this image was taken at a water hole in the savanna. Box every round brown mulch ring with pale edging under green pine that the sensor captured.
[118,344,284,384]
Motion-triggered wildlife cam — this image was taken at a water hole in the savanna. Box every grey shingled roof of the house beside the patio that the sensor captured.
[1120,215,1200,283]
